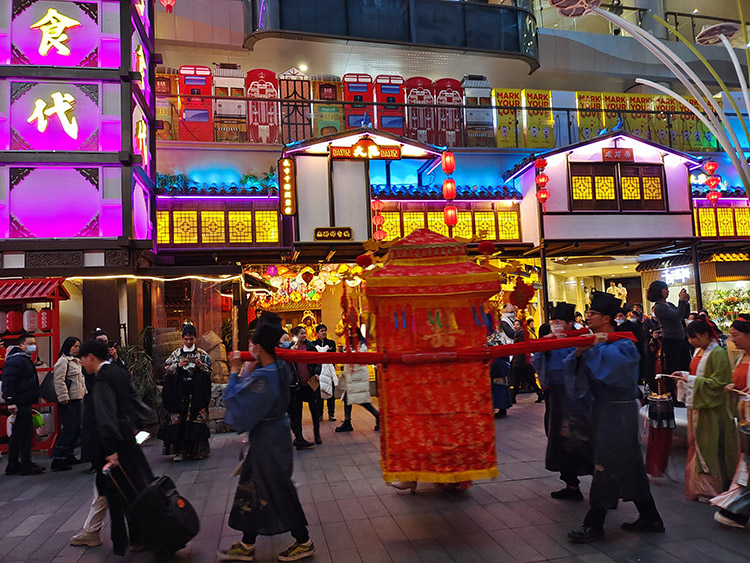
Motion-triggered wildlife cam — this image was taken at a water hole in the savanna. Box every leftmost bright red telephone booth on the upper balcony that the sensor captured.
[178,66,214,142]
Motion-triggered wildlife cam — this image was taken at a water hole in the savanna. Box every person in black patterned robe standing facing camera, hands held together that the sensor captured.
[159,324,211,461]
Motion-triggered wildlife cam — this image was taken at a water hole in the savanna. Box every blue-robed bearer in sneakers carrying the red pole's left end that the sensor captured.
[218,320,315,561]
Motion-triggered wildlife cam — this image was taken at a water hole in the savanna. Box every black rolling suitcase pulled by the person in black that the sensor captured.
[108,466,200,555]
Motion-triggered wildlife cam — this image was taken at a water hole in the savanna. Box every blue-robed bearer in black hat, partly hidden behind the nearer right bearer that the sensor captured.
[531,301,594,501]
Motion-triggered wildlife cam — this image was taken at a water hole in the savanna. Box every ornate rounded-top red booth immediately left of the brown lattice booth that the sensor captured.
[245,68,281,145]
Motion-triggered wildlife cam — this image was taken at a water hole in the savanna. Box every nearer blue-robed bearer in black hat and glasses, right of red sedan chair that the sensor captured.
[564,292,664,543]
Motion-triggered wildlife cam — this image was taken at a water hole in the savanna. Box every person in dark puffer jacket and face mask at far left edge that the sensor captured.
[2,334,44,475]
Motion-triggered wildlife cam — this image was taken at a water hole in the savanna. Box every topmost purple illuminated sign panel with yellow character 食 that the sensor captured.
[0,0,120,68]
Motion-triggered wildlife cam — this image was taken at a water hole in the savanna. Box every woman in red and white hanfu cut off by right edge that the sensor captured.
[711,314,750,528]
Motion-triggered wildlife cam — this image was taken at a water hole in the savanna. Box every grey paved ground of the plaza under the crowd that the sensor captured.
[0,395,750,563]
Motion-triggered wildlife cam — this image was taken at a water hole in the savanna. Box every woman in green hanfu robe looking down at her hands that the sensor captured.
[672,319,737,502]
